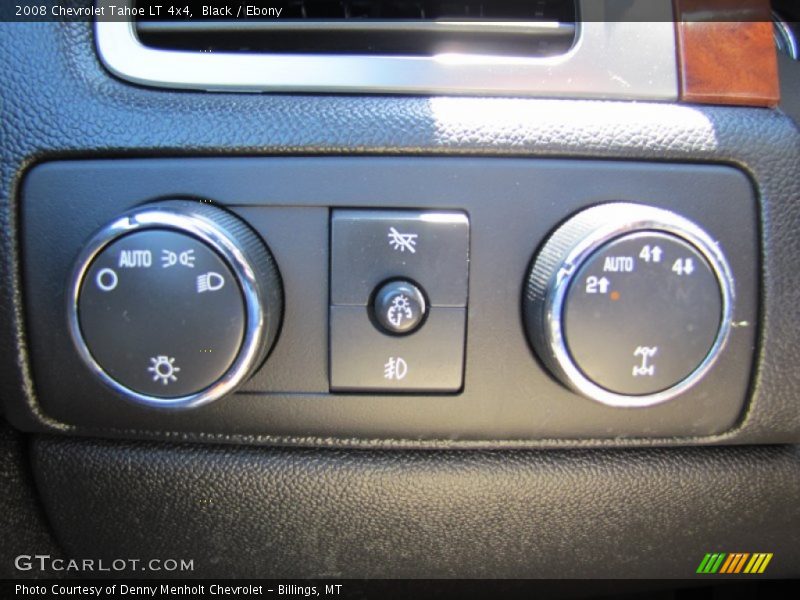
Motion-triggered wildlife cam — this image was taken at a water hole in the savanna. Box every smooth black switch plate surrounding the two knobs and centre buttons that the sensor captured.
[21,158,756,443]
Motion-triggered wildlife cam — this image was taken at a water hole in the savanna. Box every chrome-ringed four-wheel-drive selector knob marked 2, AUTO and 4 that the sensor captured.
[523,203,734,406]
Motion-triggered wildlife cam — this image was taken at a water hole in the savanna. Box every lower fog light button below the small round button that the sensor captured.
[330,306,466,392]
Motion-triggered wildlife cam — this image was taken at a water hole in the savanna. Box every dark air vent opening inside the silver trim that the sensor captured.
[136,0,577,57]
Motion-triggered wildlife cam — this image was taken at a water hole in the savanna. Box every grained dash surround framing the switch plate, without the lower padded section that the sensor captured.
[3,24,800,445]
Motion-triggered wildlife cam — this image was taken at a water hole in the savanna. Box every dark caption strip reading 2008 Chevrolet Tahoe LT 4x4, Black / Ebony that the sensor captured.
[0,0,776,22]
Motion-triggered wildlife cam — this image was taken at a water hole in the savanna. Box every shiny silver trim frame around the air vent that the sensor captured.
[95,0,678,100]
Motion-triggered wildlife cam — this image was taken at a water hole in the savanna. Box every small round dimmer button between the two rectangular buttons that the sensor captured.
[372,280,428,335]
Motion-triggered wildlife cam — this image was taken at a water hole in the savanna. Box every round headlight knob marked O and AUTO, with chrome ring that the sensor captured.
[67,200,283,408]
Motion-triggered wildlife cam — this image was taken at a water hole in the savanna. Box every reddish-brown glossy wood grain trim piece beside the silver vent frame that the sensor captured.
[674,0,780,107]
